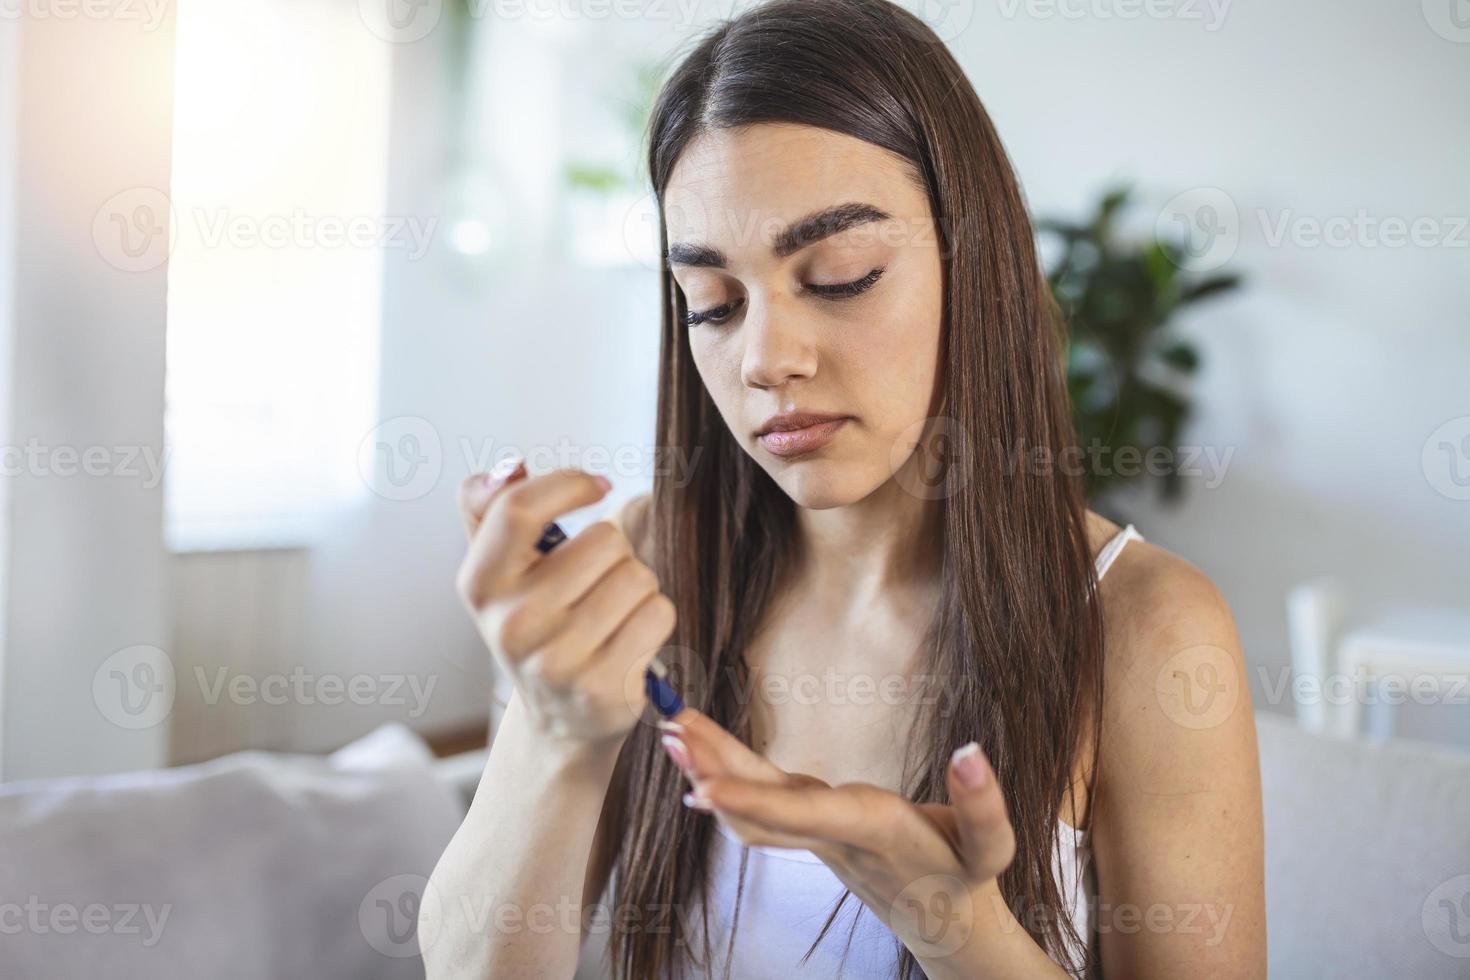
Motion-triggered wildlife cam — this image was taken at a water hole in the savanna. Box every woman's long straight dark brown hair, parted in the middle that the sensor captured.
[612,0,1103,980]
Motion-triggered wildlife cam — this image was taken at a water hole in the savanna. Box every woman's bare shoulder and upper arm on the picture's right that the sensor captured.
[1089,537,1266,977]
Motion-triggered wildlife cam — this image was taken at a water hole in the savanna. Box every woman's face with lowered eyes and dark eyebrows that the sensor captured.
[664,123,944,510]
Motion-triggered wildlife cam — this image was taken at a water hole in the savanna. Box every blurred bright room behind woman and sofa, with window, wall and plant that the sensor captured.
[0,0,1470,976]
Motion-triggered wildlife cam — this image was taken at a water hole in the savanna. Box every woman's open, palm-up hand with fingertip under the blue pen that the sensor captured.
[660,708,1016,959]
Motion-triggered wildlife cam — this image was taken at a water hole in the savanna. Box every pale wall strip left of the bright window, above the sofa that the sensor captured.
[0,7,172,779]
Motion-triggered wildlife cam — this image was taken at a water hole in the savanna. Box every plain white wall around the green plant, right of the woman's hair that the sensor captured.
[954,0,1470,734]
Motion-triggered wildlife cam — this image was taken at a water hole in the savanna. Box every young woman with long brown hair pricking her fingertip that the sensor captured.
[420,0,1266,980]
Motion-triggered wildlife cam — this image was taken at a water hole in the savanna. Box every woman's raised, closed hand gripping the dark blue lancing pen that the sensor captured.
[457,460,675,742]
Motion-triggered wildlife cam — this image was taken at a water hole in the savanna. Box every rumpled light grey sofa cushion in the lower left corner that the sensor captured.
[0,726,463,980]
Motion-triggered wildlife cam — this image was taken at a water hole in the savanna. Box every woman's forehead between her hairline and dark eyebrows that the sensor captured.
[664,123,929,251]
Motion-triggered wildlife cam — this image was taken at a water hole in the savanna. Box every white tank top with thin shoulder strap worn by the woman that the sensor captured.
[658,525,1144,980]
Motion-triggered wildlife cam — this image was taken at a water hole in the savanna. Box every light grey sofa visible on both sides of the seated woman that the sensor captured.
[0,713,1470,980]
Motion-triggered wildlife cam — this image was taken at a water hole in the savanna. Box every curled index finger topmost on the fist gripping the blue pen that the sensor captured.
[463,470,610,599]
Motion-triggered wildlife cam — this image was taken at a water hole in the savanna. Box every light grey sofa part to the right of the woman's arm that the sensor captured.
[1257,713,1470,980]
